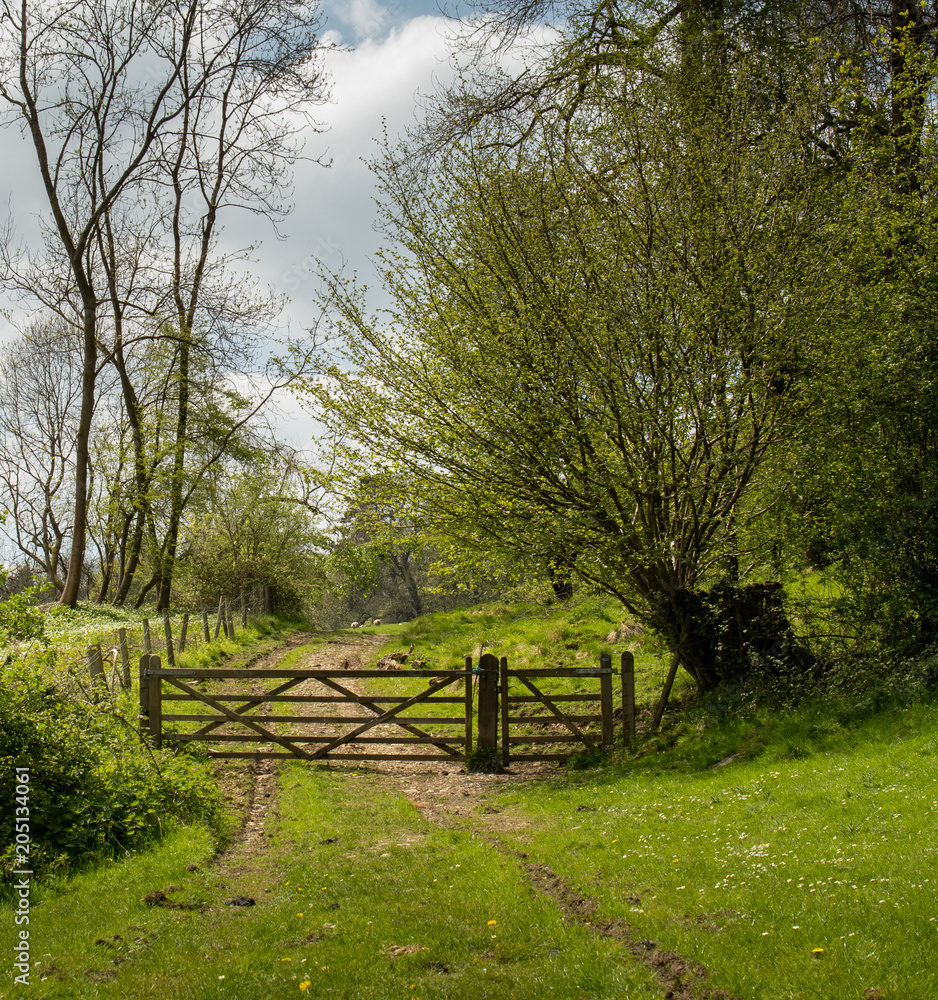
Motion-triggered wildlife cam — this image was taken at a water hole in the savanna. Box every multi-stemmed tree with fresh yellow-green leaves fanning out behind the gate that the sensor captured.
[310,43,828,688]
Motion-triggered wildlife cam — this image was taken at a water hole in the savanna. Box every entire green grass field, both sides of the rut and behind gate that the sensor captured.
[0,603,938,1000]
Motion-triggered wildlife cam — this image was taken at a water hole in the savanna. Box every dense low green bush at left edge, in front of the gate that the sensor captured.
[0,670,221,880]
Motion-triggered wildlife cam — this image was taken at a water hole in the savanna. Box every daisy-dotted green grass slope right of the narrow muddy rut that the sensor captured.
[478,704,938,1000]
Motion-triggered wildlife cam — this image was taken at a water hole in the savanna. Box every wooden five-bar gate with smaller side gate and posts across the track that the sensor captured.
[140,653,635,764]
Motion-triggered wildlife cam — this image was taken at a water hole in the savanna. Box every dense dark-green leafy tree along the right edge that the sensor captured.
[780,113,938,648]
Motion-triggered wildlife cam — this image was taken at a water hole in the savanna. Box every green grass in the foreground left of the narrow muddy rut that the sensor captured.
[9,765,660,1000]
